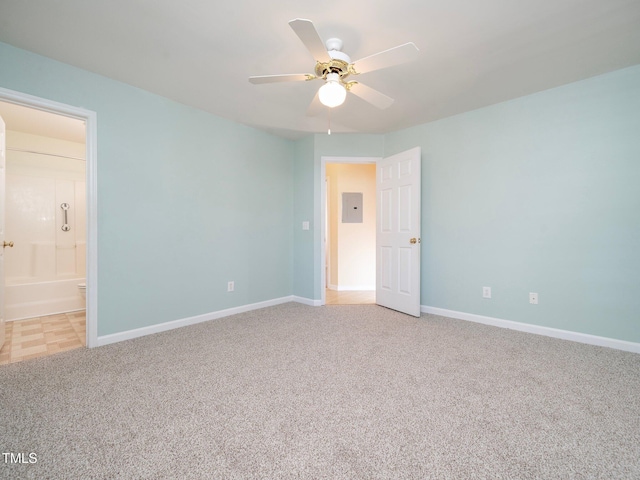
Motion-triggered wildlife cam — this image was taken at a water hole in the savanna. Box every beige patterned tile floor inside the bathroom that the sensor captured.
[0,310,86,365]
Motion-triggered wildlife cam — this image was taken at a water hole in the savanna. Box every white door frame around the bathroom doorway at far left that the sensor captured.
[0,87,98,348]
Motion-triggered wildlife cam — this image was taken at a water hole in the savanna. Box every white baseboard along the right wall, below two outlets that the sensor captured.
[420,305,640,353]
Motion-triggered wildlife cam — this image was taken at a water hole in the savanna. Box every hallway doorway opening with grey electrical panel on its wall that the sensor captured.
[322,157,376,305]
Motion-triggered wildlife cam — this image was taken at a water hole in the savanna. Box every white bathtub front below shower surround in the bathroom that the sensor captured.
[4,278,85,321]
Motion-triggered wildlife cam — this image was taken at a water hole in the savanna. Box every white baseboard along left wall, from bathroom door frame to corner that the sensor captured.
[96,295,296,347]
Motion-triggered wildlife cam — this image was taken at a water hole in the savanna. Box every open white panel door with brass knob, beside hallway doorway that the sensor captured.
[376,147,420,317]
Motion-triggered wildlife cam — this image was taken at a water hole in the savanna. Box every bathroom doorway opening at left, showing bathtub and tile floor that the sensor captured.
[0,98,88,365]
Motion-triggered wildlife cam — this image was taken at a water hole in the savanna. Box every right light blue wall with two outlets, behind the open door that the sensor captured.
[385,66,640,342]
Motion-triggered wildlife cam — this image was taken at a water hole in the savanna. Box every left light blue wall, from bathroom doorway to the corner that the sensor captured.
[0,43,294,335]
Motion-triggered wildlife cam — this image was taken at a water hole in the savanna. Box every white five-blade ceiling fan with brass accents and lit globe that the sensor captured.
[249,18,419,112]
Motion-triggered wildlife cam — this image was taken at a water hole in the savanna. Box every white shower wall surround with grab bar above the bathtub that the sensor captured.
[5,131,86,285]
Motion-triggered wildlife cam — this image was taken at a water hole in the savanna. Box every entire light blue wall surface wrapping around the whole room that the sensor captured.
[0,38,640,342]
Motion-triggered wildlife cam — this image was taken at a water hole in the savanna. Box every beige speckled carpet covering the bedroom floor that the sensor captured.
[0,303,640,479]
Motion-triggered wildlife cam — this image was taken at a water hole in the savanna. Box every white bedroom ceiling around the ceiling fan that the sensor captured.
[0,0,640,138]
